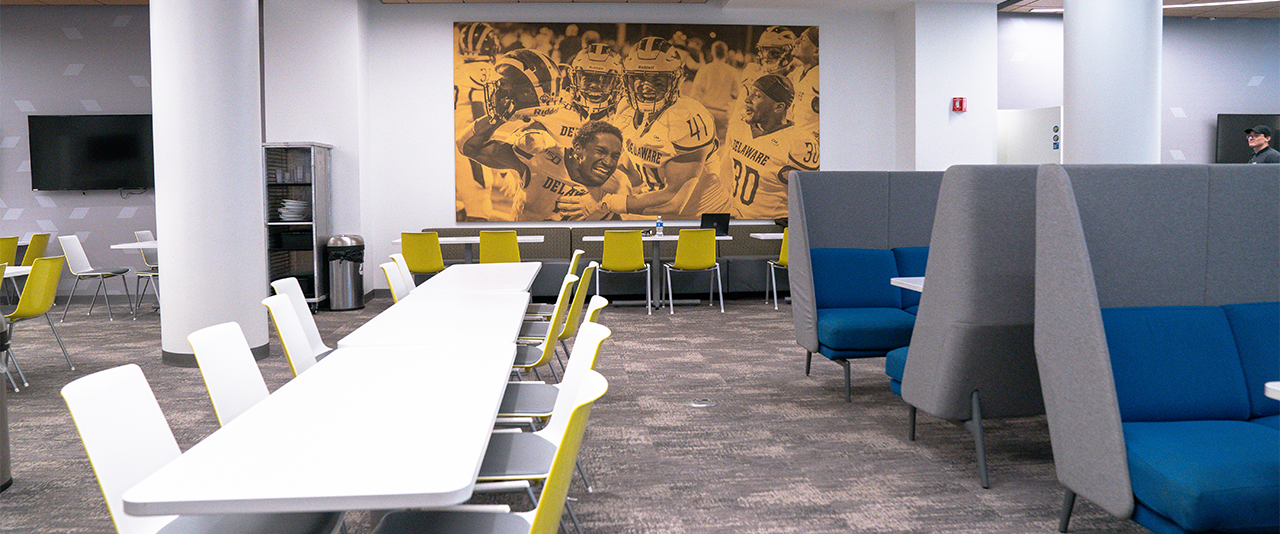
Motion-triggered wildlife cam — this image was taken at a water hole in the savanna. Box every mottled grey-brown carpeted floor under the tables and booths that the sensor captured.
[0,293,1146,534]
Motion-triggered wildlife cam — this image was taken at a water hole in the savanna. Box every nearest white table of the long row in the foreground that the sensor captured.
[123,342,516,515]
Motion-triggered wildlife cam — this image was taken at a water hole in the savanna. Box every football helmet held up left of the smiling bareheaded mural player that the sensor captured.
[484,49,561,120]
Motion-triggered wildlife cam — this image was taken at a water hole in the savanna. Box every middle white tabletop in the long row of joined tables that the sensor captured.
[338,291,529,348]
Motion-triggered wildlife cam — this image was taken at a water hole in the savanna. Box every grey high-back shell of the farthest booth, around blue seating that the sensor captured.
[787,170,942,373]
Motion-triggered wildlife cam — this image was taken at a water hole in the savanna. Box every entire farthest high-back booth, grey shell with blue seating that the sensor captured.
[788,172,942,400]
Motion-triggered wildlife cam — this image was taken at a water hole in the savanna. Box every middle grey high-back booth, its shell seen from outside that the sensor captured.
[902,165,1044,488]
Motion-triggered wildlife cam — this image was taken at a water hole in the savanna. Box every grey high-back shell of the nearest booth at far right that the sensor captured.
[1036,165,1280,528]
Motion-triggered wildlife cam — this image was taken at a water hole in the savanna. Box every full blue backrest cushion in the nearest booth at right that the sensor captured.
[1102,306,1249,423]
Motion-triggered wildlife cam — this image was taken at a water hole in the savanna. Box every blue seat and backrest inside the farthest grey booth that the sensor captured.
[805,247,929,400]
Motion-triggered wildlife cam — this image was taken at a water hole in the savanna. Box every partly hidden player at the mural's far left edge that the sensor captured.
[453,22,502,222]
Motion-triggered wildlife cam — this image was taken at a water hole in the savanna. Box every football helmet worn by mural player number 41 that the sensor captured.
[622,37,685,113]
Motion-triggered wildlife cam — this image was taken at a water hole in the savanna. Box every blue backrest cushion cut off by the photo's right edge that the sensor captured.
[1222,302,1280,417]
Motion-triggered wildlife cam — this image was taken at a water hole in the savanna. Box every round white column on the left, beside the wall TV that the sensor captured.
[151,0,268,365]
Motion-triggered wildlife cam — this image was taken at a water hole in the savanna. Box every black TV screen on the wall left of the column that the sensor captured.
[27,115,155,191]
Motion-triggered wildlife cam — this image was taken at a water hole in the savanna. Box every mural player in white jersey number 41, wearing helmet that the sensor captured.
[562,37,728,219]
